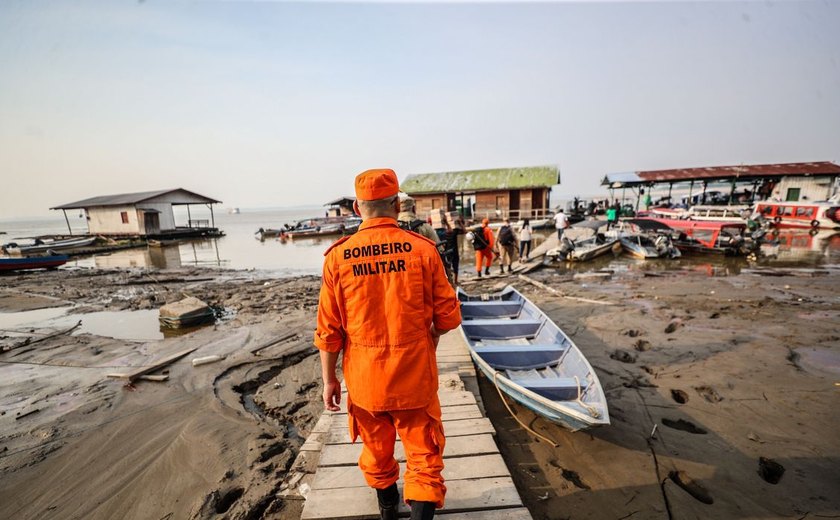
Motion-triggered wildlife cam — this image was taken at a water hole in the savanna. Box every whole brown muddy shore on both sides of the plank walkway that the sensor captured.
[0,265,840,519]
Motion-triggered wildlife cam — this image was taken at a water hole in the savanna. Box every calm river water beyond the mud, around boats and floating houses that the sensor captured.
[0,206,840,277]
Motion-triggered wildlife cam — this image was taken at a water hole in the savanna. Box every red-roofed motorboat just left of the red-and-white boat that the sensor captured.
[628,218,758,256]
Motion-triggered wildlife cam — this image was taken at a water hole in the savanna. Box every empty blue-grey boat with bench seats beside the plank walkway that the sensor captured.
[458,286,610,431]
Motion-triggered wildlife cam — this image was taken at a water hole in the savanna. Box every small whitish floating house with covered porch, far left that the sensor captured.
[50,188,221,238]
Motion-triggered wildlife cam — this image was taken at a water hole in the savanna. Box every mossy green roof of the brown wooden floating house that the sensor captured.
[400,166,560,195]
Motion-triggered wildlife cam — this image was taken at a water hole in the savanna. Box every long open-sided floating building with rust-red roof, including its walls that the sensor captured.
[601,162,840,205]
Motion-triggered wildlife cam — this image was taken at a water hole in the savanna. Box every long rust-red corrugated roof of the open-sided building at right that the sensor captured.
[637,161,840,182]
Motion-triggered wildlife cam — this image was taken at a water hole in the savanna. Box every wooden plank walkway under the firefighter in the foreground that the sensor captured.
[280,330,531,520]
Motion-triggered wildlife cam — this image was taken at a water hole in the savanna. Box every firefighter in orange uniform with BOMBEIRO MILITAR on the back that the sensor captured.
[315,170,461,520]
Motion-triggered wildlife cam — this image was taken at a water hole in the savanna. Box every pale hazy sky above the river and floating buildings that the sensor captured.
[0,0,840,218]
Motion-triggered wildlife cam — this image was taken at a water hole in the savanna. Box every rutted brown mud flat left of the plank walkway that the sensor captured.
[0,270,321,519]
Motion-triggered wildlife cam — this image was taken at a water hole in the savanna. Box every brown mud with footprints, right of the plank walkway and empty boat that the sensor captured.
[473,266,840,519]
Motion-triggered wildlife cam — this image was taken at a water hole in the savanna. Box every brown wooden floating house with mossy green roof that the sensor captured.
[400,166,560,220]
